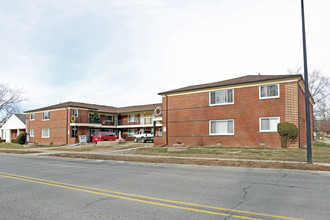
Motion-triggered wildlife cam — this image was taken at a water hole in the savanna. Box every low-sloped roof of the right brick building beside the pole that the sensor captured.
[158,74,302,95]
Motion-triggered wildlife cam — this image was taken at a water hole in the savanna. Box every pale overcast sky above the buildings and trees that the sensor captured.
[0,0,330,110]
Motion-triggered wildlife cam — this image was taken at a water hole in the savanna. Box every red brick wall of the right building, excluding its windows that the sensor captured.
[159,82,308,147]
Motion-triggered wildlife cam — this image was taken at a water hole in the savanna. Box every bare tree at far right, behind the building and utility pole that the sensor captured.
[288,67,330,120]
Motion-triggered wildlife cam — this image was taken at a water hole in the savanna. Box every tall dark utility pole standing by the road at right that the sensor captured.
[301,0,313,164]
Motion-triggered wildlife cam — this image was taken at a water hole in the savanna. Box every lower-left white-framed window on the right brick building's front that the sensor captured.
[210,119,234,135]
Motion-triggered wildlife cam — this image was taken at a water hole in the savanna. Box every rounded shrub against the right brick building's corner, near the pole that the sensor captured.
[277,122,298,148]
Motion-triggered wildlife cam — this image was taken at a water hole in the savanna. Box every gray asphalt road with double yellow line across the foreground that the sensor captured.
[0,154,330,220]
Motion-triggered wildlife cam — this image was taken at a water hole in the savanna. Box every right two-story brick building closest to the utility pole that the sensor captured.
[154,75,314,147]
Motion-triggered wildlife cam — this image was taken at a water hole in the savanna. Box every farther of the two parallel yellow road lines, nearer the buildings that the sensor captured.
[0,172,302,220]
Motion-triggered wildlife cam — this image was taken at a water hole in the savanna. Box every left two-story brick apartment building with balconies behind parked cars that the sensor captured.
[26,102,162,145]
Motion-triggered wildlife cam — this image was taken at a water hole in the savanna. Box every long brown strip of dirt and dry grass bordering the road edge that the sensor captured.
[45,153,330,171]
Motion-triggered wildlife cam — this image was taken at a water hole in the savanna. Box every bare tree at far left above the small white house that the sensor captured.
[0,84,23,123]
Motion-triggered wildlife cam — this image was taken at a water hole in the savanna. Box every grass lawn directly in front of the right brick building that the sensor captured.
[135,142,330,163]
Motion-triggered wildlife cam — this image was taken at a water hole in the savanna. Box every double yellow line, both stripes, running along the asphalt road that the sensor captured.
[0,172,302,220]
